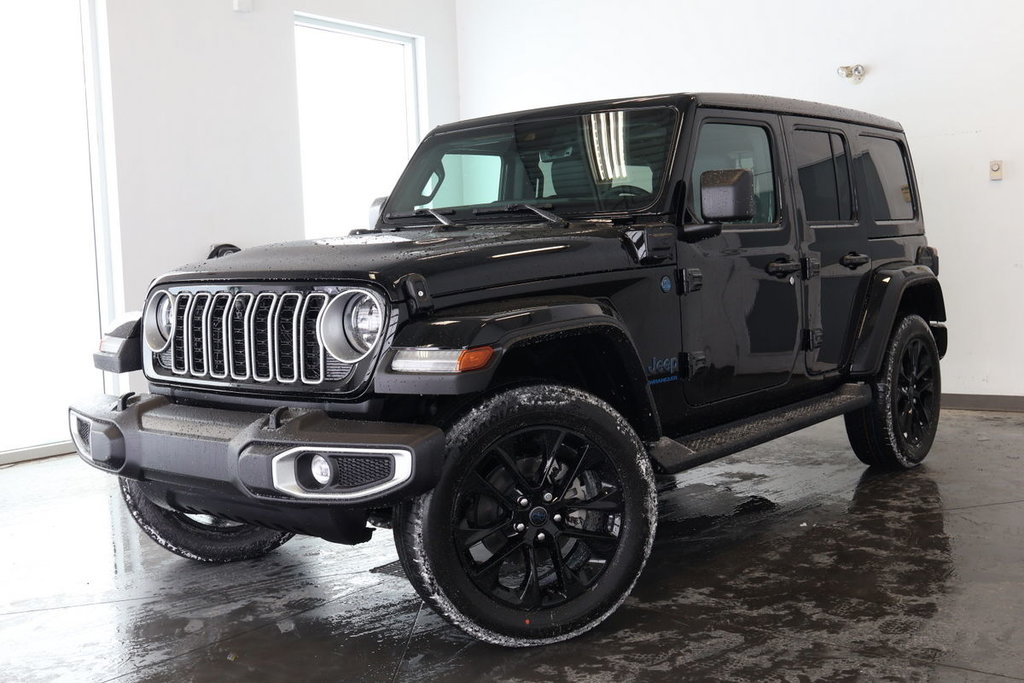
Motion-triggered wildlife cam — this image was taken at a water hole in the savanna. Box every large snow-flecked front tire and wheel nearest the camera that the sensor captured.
[394,384,657,647]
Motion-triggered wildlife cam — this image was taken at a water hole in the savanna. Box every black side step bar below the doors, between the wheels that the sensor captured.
[650,384,871,474]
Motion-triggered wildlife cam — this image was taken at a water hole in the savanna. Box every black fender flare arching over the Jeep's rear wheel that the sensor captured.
[850,263,946,376]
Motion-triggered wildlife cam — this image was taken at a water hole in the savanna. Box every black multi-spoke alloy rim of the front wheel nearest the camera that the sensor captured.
[451,425,625,610]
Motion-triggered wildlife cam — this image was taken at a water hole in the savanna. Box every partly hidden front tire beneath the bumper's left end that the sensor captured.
[119,477,294,562]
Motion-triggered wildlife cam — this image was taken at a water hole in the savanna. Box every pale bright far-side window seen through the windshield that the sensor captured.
[417,154,502,208]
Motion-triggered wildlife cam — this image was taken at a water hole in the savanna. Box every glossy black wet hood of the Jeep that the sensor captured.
[158,221,636,300]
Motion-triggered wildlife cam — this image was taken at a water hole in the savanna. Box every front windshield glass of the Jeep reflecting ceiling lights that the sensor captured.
[386,108,677,219]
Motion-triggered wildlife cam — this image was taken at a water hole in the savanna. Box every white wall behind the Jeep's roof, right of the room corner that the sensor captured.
[457,0,1024,395]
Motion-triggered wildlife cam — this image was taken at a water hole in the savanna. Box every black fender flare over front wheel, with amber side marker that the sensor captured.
[374,296,660,440]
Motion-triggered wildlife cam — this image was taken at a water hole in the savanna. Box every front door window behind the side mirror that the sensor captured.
[690,123,776,223]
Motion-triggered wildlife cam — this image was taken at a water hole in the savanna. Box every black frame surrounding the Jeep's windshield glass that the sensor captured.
[377,102,685,229]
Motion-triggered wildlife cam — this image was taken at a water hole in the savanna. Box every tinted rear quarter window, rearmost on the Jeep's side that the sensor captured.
[857,135,913,220]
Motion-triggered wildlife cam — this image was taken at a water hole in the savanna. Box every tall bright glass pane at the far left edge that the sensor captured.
[0,0,103,452]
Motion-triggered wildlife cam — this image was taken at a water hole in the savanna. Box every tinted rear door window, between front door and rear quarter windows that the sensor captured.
[793,130,853,222]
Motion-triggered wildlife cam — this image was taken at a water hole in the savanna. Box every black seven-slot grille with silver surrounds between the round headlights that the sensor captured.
[157,292,353,384]
